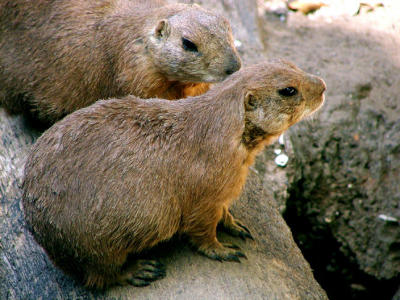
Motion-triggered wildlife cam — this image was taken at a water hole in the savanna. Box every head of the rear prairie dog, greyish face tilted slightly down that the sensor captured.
[149,5,241,82]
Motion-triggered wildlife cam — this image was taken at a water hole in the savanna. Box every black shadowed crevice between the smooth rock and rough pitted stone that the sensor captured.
[283,180,400,300]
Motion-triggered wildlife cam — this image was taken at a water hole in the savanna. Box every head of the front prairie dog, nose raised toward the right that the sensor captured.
[244,60,326,135]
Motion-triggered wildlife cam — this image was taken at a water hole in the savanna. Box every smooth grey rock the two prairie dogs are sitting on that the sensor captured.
[0,0,327,299]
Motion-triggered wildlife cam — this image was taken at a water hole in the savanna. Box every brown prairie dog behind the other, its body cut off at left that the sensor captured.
[0,0,241,124]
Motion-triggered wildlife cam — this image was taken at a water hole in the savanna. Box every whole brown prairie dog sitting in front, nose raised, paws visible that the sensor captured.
[23,60,326,288]
